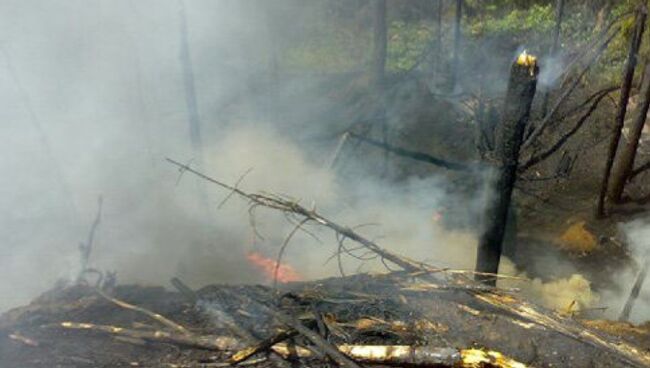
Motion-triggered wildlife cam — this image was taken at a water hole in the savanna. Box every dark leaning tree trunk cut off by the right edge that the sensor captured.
[610,64,650,202]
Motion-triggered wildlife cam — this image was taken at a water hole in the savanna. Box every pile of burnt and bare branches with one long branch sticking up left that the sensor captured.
[6,159,650,368]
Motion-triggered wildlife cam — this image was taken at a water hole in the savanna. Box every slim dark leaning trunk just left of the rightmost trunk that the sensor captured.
[596,6,648,217]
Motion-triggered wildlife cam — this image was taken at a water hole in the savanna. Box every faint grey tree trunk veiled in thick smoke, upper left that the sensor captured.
[179,0,203,167]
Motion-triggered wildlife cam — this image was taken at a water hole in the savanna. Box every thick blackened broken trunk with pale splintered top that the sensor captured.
[476,57,538,285]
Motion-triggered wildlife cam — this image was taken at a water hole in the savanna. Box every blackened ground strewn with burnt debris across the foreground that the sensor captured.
[0,274,650,368]
